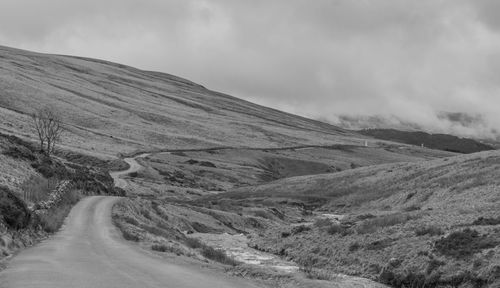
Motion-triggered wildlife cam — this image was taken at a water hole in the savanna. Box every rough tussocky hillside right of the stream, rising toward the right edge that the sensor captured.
[213,151,500,287]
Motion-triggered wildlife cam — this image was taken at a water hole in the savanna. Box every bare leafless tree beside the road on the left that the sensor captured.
[31,107,63,156]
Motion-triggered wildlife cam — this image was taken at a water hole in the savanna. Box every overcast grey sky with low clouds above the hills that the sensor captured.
[0,0,500,136]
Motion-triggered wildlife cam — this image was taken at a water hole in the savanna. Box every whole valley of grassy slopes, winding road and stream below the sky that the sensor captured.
[0,47,500,288]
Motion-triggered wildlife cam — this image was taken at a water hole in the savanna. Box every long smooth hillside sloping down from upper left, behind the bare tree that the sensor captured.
[0,46,364,156]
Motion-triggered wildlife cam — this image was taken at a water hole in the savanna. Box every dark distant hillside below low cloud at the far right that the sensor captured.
[358,129,495,154]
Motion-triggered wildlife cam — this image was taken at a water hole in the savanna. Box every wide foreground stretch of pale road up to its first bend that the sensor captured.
[0,196,264,288]
